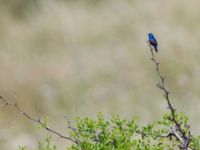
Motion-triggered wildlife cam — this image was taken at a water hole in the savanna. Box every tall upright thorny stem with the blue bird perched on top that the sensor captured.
[147,41,193,150]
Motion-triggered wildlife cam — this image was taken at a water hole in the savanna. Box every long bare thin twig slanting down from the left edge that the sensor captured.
[0,96,79,144]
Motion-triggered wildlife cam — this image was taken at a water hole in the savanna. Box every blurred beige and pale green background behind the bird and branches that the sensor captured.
[0,0,200,150]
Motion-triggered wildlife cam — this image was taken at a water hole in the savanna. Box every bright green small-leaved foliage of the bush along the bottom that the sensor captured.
[20,113,200,150]
